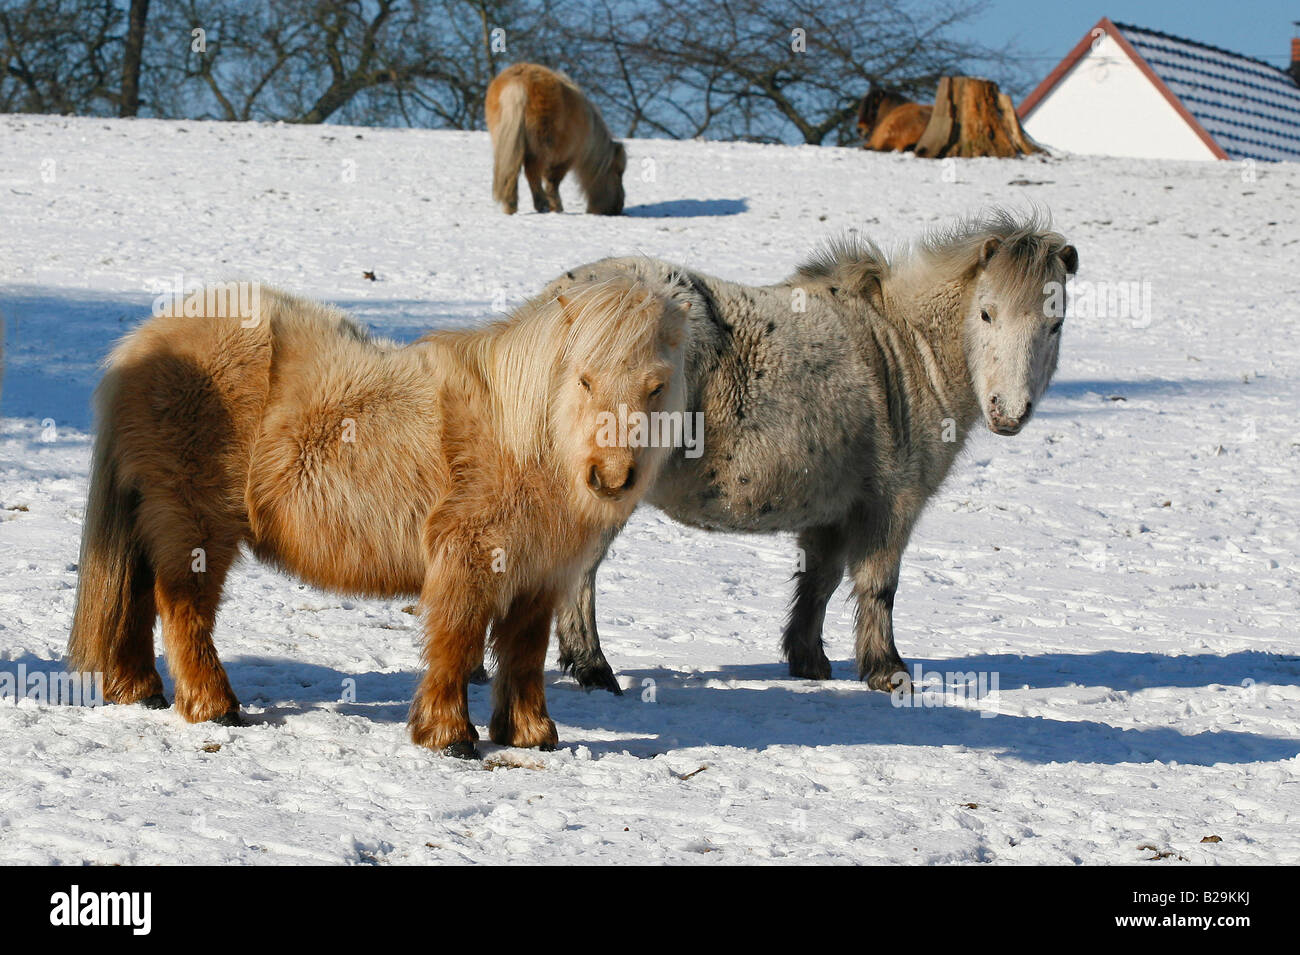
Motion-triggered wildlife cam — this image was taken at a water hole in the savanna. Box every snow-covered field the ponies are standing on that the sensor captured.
[0,117,1300,864]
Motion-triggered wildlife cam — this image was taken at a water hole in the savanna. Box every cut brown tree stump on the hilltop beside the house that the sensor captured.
[917,77,1043,159]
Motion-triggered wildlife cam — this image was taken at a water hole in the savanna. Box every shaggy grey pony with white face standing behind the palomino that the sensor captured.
[542,212,1079,693]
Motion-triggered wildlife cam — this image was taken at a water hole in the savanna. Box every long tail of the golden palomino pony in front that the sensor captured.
[68,369,153,699]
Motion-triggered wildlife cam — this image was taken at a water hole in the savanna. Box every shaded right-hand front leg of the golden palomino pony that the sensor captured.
[489,592,559,750]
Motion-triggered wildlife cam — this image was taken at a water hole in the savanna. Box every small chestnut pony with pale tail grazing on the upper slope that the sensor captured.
[488,62,628,216]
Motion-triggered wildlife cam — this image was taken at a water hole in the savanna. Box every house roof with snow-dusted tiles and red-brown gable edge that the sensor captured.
[1017,17,1300,161]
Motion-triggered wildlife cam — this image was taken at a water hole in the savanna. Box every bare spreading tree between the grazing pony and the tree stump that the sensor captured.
[579,0,991,144]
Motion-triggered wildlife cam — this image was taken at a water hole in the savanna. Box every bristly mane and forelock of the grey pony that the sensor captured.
[793,208,1066,301]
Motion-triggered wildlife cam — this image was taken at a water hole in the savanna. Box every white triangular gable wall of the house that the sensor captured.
[1023,34,1216,160]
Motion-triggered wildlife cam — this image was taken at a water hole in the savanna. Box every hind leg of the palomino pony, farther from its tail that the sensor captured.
[153,534,241,726]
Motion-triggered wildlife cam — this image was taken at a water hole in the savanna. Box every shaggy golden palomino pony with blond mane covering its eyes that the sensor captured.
[69,275,685,756]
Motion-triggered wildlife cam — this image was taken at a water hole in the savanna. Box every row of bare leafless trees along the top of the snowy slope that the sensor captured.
[0,0,1015,143]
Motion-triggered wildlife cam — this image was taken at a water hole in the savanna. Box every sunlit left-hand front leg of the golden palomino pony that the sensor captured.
[410,559,495,759]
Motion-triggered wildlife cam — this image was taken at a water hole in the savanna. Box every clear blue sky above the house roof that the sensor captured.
[953,0,1300,82]
